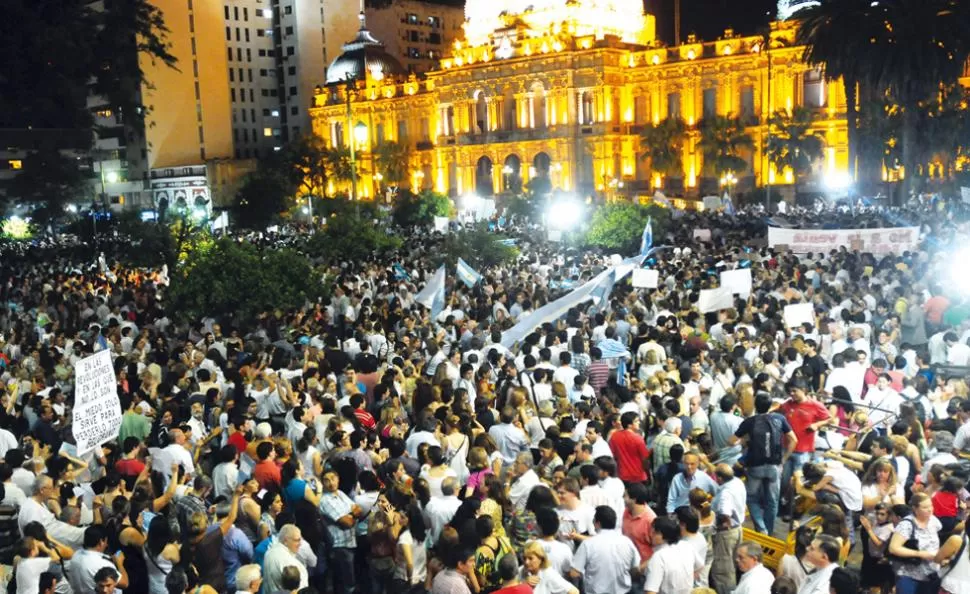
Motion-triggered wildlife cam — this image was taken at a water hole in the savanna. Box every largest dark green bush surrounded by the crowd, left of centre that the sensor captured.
[167,238,322,320]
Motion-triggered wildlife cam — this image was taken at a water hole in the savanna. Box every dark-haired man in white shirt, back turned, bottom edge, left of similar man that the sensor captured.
[569,505,644,594]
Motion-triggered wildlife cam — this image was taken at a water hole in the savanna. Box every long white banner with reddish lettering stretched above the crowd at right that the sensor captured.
[768,227,919,256]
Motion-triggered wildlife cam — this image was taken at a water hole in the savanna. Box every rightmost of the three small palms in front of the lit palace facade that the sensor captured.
[767,107,825,195]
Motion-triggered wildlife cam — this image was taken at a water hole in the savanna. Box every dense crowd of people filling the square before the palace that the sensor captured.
[0,204,970,594]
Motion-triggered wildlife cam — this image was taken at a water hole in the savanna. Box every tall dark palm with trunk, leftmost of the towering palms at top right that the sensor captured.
[795,0,886,183]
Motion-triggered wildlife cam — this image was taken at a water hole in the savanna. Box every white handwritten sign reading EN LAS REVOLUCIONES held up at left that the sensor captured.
[71,350,122,456]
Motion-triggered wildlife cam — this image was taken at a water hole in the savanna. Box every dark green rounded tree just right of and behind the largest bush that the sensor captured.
[306,210,403,261]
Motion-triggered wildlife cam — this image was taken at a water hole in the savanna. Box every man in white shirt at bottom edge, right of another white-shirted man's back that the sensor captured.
[644,516,696,594]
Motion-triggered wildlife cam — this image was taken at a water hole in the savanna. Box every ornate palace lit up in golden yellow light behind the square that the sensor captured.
[310,0,847,198]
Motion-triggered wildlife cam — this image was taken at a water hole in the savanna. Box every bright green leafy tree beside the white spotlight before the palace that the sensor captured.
[586,202,670,254]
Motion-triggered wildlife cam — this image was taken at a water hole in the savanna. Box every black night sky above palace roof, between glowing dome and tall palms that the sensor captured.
[644,0,778,44]
